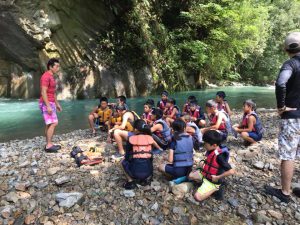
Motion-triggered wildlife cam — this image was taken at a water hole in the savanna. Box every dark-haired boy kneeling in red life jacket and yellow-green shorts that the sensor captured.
[189,130,234,201]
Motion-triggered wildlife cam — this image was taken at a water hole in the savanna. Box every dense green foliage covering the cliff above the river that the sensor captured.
[100,0,300,91]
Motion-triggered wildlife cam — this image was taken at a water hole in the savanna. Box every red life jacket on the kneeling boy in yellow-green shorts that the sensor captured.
[201,146,229,181]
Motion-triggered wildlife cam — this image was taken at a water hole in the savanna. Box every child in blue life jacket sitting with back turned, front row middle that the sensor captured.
[159,119,194,179]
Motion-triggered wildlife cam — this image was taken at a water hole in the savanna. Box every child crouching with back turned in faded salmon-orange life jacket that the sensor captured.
[122,119,159,189]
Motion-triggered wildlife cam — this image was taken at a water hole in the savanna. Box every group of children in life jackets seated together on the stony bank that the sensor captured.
[89,91,263,201]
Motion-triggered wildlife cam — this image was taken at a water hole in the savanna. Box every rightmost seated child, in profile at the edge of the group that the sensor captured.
[233,99,263,145]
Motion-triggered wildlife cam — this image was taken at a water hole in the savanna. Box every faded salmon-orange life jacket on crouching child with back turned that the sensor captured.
[128,134,154,159]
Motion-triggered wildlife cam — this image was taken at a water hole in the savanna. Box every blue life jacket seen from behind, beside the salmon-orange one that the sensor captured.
[173,133,194,167]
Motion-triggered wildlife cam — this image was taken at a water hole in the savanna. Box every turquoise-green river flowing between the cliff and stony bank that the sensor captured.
[0,86,276,142]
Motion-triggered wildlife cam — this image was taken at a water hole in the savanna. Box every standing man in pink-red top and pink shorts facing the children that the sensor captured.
[39,58,62,153]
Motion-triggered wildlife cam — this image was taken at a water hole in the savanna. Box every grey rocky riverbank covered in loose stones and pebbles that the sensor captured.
[0,110,300,225]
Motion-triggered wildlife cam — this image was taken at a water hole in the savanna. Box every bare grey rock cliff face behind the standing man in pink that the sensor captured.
[0,0,152,99]
